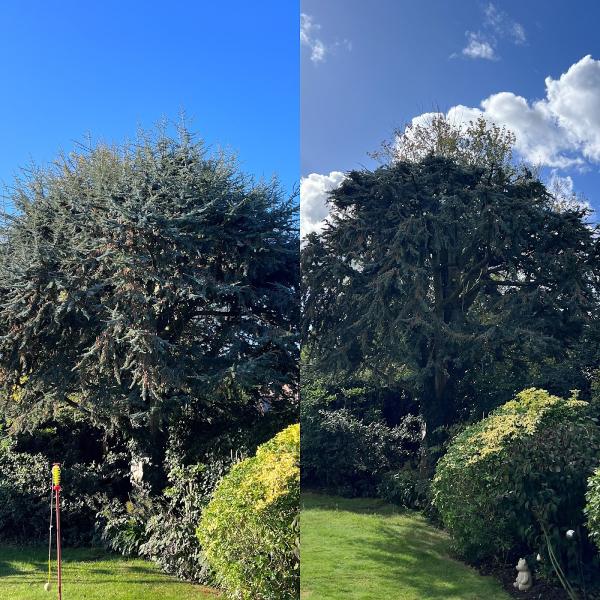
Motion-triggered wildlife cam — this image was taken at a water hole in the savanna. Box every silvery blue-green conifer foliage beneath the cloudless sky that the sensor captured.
[0,130,299,435]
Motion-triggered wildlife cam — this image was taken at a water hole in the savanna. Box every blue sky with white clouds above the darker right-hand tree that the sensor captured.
[301,0,600,234]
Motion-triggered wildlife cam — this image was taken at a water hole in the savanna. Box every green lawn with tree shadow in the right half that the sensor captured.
[300,493,509,600]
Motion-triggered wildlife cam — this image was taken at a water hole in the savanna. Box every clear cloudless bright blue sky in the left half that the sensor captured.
[0,0,299,195]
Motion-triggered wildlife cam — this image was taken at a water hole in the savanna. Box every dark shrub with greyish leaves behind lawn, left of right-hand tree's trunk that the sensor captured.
[302,408,421,496]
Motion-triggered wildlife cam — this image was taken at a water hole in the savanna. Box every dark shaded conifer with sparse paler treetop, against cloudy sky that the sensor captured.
[302,117,597,440]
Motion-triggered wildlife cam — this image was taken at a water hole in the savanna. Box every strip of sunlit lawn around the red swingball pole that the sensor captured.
[0,546,218,600]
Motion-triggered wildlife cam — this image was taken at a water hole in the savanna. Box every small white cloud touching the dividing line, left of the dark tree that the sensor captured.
[300,171,345,238]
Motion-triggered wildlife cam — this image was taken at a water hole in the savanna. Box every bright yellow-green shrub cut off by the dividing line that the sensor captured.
[197,425,300,600]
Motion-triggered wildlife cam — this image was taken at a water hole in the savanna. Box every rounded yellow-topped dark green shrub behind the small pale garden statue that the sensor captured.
[432,388,600,570]
